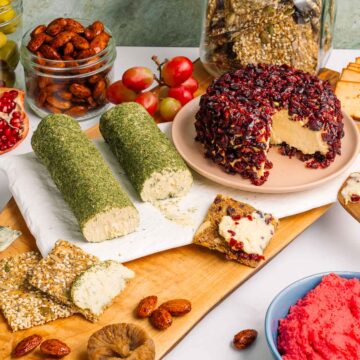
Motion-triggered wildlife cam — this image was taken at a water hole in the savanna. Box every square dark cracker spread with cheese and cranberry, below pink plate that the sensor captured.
[193,194,279,267]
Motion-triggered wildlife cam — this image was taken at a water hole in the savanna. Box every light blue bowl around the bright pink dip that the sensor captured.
[265,271,360,360]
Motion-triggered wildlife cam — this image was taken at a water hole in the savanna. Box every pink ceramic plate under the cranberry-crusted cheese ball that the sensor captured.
[172,98,360,193]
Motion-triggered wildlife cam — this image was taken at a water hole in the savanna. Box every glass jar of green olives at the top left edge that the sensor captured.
[0,0,23,87]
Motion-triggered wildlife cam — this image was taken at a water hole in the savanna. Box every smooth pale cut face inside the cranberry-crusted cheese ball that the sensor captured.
[270,109,329,154]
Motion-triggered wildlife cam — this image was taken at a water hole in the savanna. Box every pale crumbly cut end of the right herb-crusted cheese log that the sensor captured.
[140,170,193,202]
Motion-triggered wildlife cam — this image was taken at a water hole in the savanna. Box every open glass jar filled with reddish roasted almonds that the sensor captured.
[20,19,116,121]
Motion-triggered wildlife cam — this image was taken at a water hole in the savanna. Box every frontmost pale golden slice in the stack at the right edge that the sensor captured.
[335,80,360,120]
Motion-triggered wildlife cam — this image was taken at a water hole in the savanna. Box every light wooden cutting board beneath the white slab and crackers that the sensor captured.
[0,61,356,360]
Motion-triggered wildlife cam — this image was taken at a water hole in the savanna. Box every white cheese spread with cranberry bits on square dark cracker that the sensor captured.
[219,211,275,255]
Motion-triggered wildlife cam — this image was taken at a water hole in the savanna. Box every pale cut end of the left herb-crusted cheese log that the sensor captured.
[82,206,139,242]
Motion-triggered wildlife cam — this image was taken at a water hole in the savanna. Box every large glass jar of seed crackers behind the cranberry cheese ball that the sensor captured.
[200,0,336,76]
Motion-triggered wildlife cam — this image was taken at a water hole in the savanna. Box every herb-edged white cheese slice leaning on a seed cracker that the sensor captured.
[71,260,135,316]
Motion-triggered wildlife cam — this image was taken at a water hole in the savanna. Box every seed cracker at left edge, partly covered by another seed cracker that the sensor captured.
[0,251,73,331]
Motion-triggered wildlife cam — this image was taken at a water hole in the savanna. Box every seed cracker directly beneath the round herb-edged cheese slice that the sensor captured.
[29,240,99,322]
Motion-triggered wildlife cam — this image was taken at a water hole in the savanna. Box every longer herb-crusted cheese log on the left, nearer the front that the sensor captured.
[31,115,139,242]
